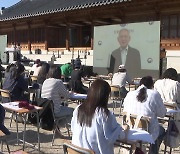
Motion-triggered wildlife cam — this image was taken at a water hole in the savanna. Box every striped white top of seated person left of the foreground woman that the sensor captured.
[41,78,70,115]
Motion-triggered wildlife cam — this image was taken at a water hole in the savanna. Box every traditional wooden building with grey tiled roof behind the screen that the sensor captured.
[0,0,180,75]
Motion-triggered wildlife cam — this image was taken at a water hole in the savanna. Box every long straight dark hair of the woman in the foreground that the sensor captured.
[78,79,111,127]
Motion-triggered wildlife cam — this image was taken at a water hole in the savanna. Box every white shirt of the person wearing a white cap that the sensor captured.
[112,72,132,87]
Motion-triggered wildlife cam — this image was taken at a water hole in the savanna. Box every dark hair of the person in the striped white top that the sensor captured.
[47,65,61,79]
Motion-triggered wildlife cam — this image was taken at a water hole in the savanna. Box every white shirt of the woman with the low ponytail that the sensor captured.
[123,85,166,141]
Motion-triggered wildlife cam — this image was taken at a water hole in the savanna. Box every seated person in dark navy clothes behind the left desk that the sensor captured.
[3,63,28,102]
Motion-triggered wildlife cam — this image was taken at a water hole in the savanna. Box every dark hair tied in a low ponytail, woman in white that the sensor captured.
[137,76,153,102]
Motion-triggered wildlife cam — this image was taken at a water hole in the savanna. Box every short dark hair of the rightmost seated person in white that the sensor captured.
[162,68,178,81]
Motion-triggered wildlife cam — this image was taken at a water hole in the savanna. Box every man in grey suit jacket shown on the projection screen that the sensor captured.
[109,29,141,78]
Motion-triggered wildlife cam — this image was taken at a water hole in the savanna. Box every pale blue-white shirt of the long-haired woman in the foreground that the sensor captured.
[71,106,125,154]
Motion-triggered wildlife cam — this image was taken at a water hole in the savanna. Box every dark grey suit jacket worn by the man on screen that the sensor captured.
[109,46,141,78]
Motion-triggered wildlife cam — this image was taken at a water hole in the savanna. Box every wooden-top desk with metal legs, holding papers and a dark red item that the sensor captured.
[2,102,42,152]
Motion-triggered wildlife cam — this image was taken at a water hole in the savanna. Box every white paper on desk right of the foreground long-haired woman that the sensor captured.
[127,129,154,144]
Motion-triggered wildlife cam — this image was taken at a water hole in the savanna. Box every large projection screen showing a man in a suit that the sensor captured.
[93,21,160,77]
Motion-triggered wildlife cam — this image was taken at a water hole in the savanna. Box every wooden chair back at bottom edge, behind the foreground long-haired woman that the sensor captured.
[63,141,95,154]
